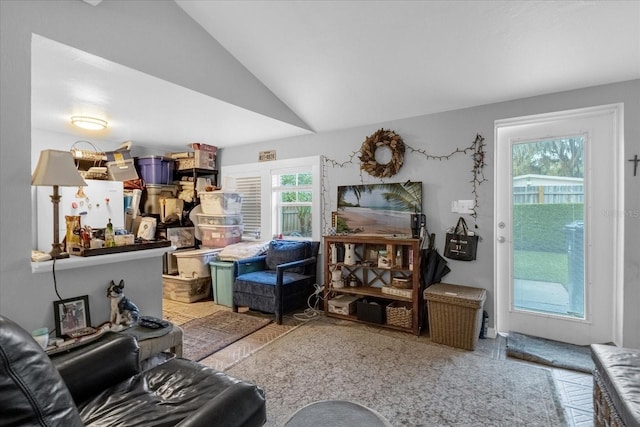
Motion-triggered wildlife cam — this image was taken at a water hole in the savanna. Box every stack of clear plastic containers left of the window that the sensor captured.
[197,191,244,248]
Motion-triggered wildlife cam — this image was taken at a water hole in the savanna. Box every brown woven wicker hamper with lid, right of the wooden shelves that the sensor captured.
[424,283,487,350]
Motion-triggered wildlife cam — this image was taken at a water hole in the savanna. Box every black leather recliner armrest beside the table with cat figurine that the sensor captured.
[51,332,140,404]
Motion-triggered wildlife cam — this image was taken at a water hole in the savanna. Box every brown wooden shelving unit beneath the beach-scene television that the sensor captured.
[324,235,422,335]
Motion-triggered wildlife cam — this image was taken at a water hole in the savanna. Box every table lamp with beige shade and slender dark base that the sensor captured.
[31,150,87,259]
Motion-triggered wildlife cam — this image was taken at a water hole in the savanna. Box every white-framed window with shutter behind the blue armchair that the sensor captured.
[221,157,321,240]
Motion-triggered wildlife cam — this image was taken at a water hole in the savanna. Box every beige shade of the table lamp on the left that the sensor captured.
[31,150,87,187]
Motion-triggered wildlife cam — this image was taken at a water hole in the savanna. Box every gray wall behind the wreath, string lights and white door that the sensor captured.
[219,80,640,347]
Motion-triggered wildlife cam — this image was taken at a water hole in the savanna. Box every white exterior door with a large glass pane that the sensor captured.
[494,105,623,345]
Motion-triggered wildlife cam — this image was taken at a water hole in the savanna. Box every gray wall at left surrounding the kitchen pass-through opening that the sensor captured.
[0,0,288,330]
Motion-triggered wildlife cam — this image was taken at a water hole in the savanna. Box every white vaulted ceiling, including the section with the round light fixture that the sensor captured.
[32,0,640,147]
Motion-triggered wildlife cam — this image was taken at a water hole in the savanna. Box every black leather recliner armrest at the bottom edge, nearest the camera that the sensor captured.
[178,381,267,427]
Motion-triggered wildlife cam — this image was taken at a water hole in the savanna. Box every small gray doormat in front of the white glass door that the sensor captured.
[507,332,595,374]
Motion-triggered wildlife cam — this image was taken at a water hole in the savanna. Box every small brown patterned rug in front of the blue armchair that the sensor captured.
[180,311,271,361]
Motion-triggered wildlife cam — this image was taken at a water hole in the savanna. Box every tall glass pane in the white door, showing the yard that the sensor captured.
[511,136,585,319]
